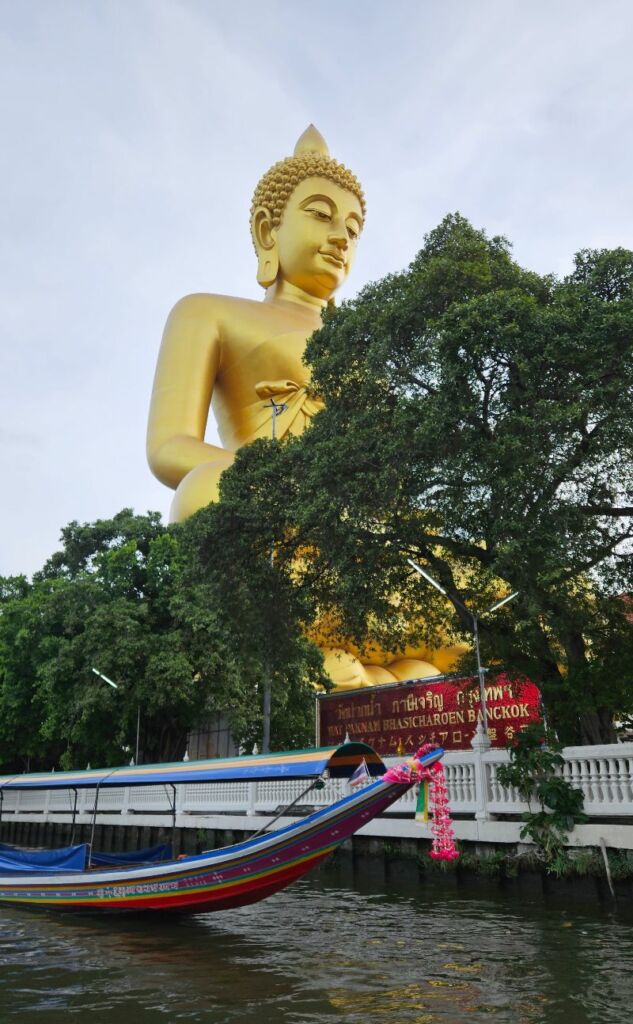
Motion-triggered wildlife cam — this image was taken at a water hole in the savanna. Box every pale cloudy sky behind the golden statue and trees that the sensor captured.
[0,0,633,575]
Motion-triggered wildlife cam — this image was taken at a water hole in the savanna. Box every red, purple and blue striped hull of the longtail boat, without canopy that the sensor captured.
[0,781,409,912]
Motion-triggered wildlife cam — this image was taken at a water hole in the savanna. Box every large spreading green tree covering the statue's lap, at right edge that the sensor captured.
[213,215,633,742]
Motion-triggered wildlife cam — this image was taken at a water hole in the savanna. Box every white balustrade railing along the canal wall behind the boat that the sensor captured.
[2,734,633,820]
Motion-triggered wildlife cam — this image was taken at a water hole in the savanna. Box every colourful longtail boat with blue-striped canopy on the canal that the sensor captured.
[0,743,444,912]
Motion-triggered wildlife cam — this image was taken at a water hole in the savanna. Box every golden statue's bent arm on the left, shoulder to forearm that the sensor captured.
[147,295,233,487]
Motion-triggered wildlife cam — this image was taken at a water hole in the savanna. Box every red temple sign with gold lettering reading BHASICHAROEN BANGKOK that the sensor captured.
[319,675,541,756]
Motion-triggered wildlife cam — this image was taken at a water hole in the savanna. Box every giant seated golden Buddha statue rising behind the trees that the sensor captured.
[147,125,461,689]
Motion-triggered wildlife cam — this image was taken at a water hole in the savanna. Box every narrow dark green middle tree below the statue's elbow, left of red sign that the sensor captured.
[178,441,329,750]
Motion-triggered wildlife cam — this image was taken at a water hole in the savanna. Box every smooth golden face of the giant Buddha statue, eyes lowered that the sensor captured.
[270,177,363,300]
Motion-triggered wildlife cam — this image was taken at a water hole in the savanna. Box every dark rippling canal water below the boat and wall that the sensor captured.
[0,866,633,1024]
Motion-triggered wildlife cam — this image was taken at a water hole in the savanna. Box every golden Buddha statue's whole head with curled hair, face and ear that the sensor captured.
[251,125,365,301]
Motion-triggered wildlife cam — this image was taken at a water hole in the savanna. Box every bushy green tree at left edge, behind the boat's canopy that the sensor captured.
[0,510,213,767]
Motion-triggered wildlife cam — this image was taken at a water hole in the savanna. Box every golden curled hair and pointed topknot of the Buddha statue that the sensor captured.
[251,125,366,250]
